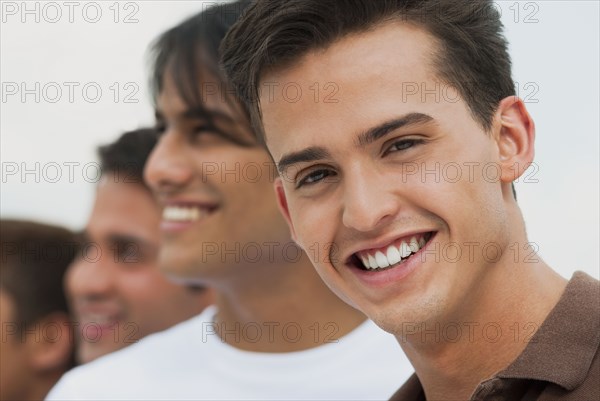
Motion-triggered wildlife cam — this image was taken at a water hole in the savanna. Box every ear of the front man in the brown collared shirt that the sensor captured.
[496,96,535,184]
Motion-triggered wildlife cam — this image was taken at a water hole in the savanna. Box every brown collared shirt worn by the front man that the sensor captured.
[390,272,600,401]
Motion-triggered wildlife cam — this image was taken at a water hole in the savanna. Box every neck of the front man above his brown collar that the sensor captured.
[399,235,566,400]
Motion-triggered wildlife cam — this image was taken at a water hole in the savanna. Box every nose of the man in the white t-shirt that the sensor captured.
[144,130,193,192]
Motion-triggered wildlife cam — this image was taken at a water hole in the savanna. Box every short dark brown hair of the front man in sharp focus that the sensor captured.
[221,0,515,140]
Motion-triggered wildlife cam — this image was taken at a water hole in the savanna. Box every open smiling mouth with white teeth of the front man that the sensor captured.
[350,231,435,272]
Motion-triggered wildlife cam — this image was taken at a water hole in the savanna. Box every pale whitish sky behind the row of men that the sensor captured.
[0,1,600,278]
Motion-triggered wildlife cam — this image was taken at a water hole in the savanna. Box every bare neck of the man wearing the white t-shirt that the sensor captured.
[215,256,365,352]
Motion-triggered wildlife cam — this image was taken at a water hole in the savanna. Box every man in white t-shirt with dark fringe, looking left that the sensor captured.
[48,1,412,400]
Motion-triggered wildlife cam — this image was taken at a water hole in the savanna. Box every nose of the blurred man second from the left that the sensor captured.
[65,252,114,300]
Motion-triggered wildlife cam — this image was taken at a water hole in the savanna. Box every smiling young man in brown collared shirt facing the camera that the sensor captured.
[222,0,600,401]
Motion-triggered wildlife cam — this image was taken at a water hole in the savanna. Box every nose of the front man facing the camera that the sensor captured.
[342,165,399,232]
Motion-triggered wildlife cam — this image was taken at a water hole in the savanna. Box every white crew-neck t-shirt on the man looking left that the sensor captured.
[46,306,413,401]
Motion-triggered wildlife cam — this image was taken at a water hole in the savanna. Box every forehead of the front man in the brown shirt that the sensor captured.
[260,23,436,151]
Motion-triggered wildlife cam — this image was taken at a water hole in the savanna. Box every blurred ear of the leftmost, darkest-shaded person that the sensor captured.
[26,312,74,373]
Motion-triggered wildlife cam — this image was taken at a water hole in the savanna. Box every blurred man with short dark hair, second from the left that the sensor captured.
[65,129,213,363]
